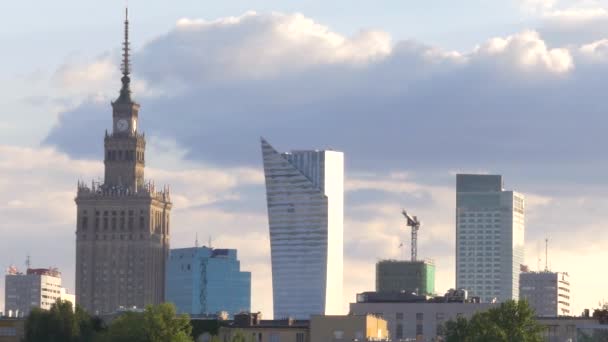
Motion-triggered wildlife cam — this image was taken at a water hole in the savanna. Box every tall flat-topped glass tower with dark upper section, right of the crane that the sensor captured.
[456,174,524,301]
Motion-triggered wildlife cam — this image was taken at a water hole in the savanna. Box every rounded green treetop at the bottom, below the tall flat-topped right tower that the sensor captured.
[445,301,544,342]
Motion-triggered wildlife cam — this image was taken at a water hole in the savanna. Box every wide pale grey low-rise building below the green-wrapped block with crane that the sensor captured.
[350,290,497,341]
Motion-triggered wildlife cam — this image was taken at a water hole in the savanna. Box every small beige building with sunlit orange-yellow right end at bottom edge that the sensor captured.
[310,315,389,342]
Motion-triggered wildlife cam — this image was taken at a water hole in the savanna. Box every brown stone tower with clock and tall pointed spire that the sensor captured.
[76,9,171,313]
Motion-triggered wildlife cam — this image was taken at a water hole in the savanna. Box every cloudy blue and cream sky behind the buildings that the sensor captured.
[0,0,608,317]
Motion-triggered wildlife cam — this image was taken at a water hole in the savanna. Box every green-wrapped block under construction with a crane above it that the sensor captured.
[376,260,435,296]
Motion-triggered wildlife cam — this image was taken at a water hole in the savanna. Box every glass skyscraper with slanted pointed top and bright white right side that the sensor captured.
[262,139,344,319]
